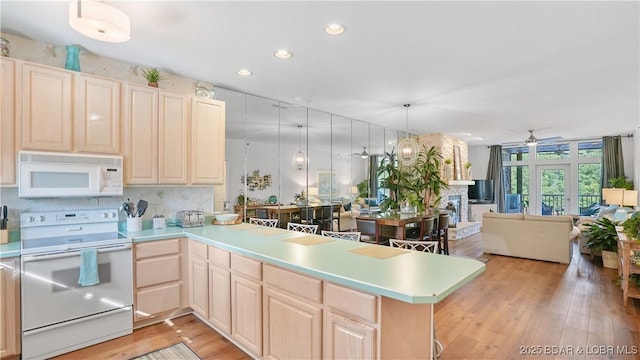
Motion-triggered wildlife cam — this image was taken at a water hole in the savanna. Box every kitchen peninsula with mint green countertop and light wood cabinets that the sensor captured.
[129,223,485,359]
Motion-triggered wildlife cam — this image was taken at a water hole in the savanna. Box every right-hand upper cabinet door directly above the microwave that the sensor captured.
[73,74,120,154]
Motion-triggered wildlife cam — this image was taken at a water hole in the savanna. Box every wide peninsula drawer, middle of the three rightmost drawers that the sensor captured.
[264,265,322,302]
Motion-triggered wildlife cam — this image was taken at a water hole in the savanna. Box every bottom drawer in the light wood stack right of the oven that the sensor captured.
[136,283,182,318]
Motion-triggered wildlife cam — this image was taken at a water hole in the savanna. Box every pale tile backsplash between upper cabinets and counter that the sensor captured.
[0,186,215,230]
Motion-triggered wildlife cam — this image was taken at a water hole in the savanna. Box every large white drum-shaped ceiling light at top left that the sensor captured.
[69,0,131,43]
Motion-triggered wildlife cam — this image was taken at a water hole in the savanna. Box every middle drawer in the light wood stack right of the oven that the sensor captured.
[136,255,180,288]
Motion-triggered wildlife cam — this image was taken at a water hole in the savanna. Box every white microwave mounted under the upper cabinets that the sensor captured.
[18,151,123,198]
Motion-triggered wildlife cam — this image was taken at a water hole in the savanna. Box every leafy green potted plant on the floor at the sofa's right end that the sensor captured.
[584,217,618,269]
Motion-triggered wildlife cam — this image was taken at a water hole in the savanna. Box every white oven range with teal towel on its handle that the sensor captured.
[20,209,133,359]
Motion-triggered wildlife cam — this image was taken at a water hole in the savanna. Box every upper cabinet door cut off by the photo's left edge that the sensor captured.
[0,57,20,185]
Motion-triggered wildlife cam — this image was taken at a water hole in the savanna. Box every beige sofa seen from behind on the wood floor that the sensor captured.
[481,213,580,264]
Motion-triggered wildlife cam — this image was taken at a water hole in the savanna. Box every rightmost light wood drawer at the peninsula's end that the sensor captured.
[324,283,378,322]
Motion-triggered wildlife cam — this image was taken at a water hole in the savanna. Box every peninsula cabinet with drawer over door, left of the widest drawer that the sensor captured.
[231,254,262,357]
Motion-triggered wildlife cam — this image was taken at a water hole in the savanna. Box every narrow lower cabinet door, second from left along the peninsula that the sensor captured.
[209,265,231,334]
